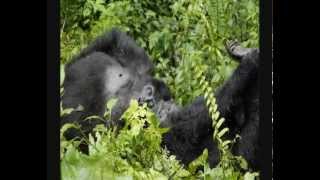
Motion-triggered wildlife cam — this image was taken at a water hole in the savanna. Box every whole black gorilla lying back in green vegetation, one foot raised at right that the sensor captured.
[61,29,259,169]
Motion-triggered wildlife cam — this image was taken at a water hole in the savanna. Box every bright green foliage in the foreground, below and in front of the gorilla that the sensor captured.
[60,100,257,180]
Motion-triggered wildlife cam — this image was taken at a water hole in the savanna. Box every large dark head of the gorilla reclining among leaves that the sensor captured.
[61,29,176,138]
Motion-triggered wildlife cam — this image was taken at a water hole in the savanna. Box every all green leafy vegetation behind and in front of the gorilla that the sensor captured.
[60,0,259,180]
